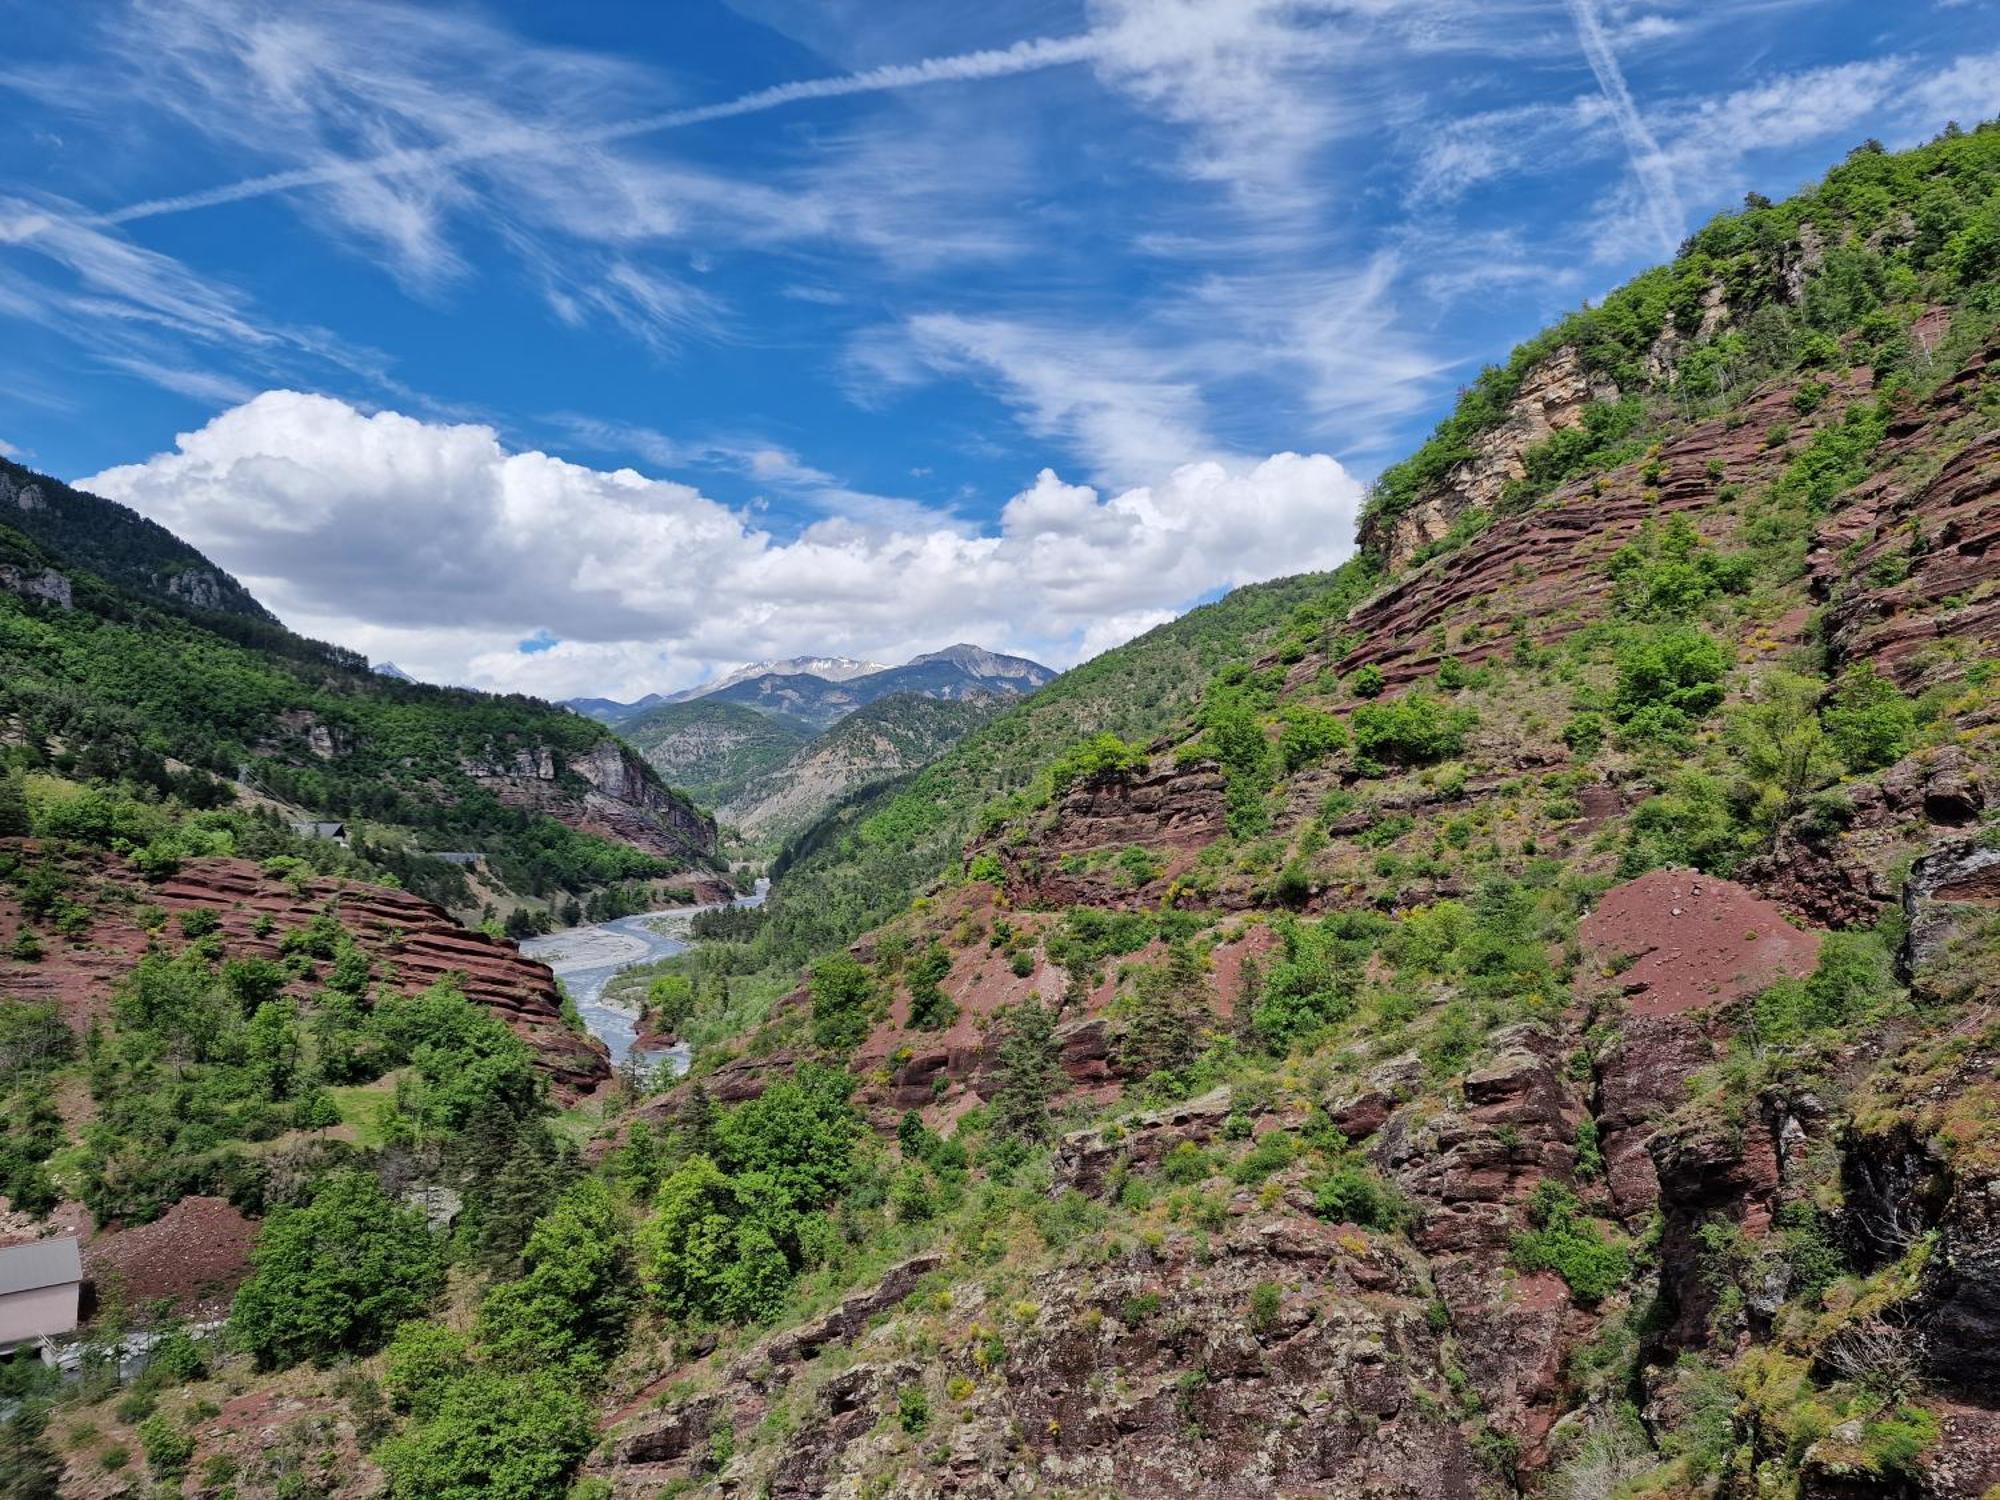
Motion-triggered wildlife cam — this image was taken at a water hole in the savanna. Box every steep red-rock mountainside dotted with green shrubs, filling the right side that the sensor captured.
[572,130,2000,1500]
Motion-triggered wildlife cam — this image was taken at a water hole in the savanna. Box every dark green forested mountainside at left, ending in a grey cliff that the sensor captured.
[0,476,714,916]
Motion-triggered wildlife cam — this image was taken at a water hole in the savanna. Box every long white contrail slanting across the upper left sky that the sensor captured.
[82,32,1102,226]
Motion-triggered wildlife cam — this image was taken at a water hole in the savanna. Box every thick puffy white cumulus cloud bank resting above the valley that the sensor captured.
[80,390,1362,696]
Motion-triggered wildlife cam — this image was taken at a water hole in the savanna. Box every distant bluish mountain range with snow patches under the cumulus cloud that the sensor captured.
[564,644,1056,748]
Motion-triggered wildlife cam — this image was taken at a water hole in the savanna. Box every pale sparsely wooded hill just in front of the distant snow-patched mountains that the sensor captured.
[720,692,1000,842]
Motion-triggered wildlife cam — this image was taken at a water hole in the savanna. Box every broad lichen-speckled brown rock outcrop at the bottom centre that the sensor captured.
[592,1202,1498,1500]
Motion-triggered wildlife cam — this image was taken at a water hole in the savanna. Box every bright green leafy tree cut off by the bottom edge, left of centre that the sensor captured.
[376,1370,596,1500]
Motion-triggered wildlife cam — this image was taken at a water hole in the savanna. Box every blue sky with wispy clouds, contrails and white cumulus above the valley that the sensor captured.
[0,0,2000,694]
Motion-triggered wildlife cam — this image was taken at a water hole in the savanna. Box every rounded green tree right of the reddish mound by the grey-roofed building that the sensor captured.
[230,1172,444,1370]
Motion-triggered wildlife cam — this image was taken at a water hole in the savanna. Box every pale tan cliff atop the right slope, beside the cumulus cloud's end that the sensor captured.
[1360,346,1618,572]
